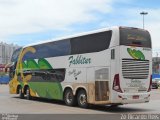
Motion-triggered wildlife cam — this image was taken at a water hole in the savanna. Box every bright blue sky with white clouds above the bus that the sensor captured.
[0,0,160,56]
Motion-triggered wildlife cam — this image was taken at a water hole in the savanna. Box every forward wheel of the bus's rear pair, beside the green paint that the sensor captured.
[64,89,76,106]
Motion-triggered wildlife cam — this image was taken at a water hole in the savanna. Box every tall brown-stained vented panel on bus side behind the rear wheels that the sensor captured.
[95,67,109,101]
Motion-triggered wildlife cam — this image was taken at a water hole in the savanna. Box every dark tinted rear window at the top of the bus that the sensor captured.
[120,28,151,48]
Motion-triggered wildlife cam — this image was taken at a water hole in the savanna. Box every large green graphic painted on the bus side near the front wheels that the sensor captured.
[20,58,63,99]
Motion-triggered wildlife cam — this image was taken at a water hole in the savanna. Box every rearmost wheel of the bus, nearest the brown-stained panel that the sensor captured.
[77,90,88,108]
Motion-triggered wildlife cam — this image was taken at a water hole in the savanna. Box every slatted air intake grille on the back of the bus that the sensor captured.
[122,59,149,79]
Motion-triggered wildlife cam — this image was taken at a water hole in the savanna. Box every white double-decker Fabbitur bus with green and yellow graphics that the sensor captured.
[9,27,152,108]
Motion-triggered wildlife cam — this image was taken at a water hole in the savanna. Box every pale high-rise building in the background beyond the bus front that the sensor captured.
[0,42,20,64]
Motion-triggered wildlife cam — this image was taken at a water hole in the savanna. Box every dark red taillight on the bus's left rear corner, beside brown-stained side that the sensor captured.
[112,74,122,93]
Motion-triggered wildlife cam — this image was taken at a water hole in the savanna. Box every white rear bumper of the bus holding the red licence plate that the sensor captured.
[112,92,150,104]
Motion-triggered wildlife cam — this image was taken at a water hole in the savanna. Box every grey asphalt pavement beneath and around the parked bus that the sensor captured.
[0,85,160,119]
